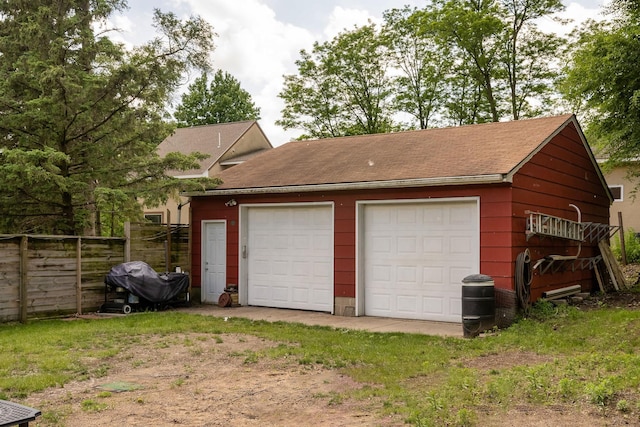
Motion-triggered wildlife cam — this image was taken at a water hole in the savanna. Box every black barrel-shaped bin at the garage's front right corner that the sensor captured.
[462,274,496,338]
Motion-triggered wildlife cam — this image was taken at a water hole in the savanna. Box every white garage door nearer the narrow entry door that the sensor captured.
[247,205,333,312]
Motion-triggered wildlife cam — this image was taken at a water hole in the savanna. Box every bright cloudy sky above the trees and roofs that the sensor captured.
[110,0,608,146]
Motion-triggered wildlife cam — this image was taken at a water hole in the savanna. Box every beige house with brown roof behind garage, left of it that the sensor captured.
[144,121,273,224]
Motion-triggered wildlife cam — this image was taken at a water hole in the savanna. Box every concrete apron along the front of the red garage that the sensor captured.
[179,304,463,338]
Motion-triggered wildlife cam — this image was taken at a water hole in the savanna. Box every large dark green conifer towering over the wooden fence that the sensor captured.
[0,0,218,234]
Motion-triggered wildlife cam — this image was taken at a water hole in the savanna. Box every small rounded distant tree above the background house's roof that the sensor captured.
[174,70,260,127]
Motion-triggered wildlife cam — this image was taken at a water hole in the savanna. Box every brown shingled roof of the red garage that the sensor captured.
[193,114,595,195]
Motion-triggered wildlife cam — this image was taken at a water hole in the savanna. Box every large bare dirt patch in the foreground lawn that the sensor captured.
[24,334,403,427]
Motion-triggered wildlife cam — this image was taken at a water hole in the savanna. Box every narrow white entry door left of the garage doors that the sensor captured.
[201,221,227,304]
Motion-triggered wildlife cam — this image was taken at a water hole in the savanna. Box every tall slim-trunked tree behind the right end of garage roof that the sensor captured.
[426,0,563,121]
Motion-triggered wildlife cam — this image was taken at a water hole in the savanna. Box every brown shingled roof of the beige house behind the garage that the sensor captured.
[158,120,258,177]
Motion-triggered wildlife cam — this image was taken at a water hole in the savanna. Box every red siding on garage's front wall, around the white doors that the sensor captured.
[191,186,512,297]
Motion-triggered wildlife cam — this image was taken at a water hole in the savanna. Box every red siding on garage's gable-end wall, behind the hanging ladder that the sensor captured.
[512,125,609,300]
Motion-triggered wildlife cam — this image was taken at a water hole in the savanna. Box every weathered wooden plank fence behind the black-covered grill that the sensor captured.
[0,224,190,322]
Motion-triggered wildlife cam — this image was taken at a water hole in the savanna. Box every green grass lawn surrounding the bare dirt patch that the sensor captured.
[0,303,640,426]
